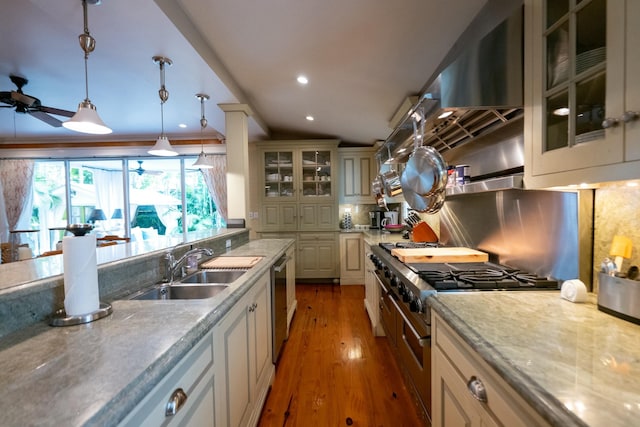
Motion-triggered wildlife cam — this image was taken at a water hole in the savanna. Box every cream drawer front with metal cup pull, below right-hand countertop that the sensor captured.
[433,315,548,427]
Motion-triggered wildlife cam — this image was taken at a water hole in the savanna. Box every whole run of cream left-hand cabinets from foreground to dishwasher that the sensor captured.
[120,273,275,427]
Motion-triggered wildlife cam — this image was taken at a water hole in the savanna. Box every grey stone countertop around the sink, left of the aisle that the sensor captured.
[0,239,293,426]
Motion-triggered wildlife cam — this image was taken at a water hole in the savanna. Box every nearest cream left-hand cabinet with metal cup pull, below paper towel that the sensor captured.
[120,333,219,427]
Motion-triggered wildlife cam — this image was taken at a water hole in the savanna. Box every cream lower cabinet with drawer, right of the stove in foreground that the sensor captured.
[431,313,549,427]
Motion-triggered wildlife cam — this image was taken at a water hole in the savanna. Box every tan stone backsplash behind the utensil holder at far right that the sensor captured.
[593,186,640,292]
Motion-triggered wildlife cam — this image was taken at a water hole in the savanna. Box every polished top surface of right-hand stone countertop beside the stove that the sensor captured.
[428,292,640,427]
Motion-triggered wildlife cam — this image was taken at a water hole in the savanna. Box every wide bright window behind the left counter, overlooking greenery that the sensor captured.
[32,157,216,247]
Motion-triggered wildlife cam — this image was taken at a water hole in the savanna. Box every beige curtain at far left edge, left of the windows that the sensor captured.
[0,159,35,242]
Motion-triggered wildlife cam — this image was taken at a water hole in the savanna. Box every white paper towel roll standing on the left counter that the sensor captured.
[62,234,100,316]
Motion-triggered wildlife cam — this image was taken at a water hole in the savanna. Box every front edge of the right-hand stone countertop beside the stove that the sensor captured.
[427,295,588,427]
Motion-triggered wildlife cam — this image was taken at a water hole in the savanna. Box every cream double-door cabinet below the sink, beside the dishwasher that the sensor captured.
[213,274,275,427]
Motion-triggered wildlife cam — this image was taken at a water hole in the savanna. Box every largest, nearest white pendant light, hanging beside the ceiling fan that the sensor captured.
[62,0,112,135]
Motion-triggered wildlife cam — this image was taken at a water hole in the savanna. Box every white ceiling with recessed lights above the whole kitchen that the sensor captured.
[0,0,486,144]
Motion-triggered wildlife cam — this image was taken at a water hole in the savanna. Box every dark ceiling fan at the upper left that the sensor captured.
[0,75,75,127]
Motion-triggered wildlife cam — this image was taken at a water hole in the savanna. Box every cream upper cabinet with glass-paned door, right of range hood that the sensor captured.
[525,0,640,188]
